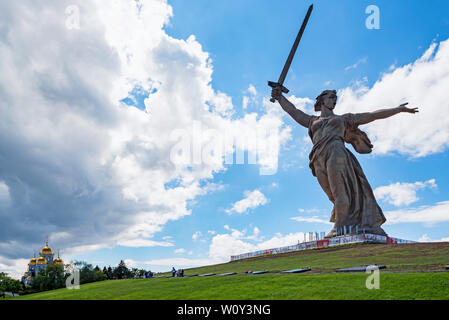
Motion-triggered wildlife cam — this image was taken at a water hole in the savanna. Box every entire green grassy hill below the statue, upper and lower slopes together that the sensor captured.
[8,243,449,300]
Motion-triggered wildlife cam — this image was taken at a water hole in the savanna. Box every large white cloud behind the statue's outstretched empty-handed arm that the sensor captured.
[336,40,449,157]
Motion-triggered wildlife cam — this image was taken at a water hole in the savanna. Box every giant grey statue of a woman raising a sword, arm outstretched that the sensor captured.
[268,6,418,238]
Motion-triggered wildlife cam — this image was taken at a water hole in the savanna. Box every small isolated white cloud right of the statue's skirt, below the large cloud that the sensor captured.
[374,179,437,207]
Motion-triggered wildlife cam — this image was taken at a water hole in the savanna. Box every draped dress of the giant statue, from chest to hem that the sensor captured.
[308,113,386,237]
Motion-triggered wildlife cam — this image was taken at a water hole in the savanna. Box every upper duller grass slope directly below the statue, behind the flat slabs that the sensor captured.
[163,242,449,275]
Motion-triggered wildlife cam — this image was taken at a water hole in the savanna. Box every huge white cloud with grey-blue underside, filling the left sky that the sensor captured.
[0,0,290,276]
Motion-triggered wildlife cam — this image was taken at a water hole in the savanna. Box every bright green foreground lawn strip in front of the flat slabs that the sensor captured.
[10,272,449,300]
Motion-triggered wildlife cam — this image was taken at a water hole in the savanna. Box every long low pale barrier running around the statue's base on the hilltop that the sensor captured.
[231,233,415,261]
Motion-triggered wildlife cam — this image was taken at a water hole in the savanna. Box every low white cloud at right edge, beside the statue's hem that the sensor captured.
[385,201,449,224]
